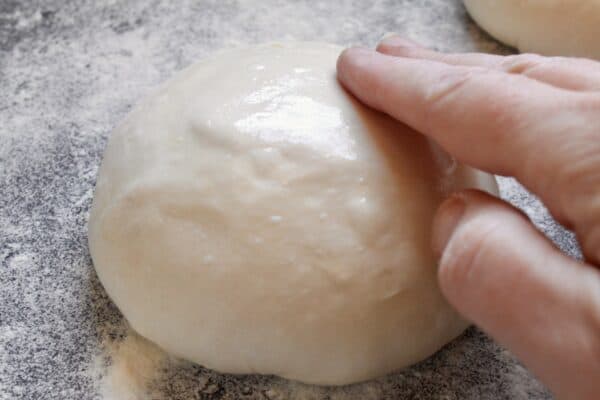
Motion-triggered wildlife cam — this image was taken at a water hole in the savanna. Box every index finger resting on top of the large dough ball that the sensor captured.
[338,48,600,241]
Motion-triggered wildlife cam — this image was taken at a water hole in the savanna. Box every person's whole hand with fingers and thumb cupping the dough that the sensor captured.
[338,36,600,399]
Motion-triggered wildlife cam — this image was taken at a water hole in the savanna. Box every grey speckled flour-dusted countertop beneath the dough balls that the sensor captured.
[0,0,576,400]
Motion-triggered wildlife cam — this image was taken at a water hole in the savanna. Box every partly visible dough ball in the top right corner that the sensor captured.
[463,0,600,59]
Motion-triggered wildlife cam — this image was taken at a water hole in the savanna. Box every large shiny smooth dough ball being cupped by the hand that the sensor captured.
[89,43,496,385]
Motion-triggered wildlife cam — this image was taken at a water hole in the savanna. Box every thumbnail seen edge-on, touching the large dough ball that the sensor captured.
[432,195,467,257]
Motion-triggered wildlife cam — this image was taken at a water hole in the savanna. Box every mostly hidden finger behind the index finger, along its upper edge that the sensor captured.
[377,36,600,91]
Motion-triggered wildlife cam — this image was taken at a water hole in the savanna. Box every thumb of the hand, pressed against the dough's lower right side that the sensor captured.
[434,191,600,399]
